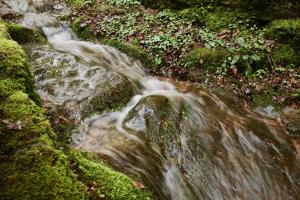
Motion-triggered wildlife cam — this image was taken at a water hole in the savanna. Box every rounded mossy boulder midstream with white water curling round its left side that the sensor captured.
[124,95,181,155]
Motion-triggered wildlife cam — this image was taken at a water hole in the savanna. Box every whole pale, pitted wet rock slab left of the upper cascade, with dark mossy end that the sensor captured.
[25,44,133,120]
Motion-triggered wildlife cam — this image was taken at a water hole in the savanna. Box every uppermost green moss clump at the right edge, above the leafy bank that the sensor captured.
[267,19,300,49]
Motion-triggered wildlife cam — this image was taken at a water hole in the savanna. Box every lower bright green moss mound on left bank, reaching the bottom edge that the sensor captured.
[0,91,150,199]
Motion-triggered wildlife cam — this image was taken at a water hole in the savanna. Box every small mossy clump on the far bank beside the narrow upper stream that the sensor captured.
[71,17,96,40]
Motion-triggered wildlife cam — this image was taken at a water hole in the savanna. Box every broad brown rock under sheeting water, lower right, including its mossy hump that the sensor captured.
[123,91,299,199]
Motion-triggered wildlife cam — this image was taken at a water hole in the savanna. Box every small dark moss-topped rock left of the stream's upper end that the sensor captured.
[8,23,47,44]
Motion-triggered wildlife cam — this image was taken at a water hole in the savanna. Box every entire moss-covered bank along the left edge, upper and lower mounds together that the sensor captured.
[0,19,151,200]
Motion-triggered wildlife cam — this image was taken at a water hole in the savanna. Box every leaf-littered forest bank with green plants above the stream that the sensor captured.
[68,0,300,110]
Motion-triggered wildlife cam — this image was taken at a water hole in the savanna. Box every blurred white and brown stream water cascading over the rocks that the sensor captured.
[2,0,300,200]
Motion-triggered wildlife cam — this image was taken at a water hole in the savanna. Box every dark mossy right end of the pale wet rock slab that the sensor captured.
[82,73,133,117]
